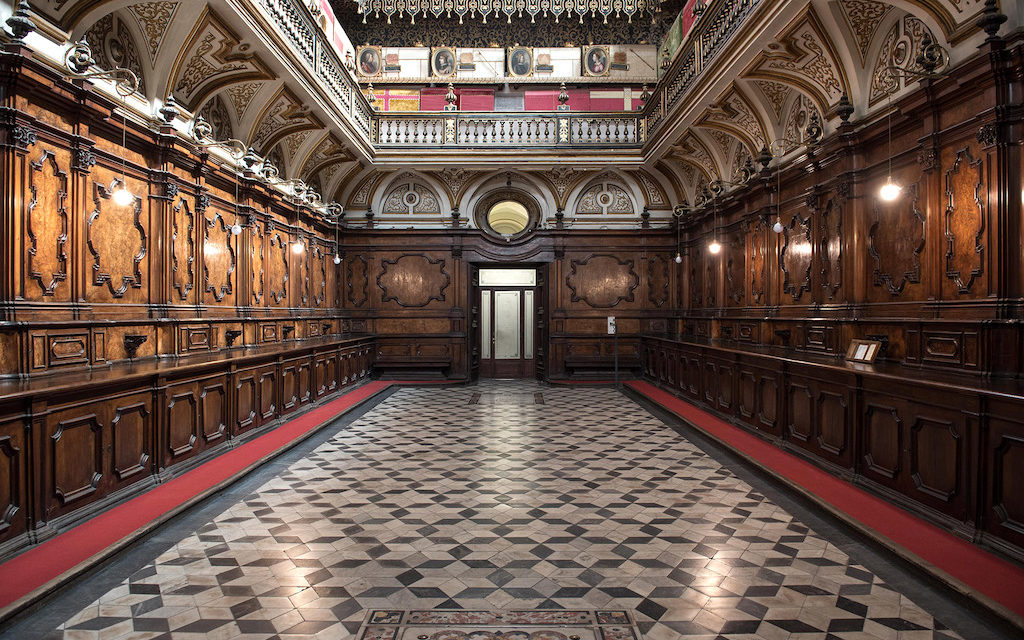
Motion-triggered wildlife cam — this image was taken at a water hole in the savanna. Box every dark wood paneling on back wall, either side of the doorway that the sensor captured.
[341,232,677,379]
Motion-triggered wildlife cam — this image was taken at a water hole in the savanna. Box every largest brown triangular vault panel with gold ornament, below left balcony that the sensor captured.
[171,10,273,110]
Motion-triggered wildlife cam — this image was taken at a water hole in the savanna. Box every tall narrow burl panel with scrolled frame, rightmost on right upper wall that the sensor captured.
[943,147,985,294]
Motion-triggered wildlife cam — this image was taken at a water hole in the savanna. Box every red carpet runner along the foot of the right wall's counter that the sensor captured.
[626,381,1024,615]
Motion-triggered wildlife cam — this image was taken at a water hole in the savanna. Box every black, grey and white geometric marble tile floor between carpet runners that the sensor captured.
[46,382,958,640]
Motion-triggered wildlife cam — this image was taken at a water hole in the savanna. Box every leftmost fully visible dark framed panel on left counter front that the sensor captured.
[50,411,103,506]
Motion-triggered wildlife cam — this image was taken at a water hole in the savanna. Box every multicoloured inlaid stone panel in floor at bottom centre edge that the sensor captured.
[359,609,640,640]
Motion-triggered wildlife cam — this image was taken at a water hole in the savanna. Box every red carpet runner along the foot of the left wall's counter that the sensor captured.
[0,381,395,612]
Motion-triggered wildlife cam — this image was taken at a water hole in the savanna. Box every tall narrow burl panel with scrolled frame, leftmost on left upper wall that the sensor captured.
[25,150,69,300]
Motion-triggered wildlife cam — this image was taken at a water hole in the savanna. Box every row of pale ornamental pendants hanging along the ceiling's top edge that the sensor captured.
[356,0,663,25]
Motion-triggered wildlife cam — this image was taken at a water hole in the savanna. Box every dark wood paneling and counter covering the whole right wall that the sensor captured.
[643,38,1024,560]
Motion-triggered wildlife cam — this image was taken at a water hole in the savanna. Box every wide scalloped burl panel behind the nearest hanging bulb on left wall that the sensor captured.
[86,182,147,298]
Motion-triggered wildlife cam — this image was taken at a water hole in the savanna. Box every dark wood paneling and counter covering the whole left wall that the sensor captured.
[0,51,376,557]
